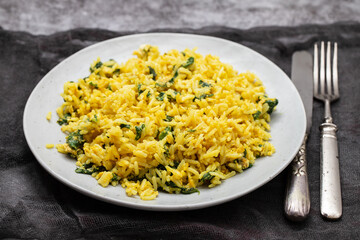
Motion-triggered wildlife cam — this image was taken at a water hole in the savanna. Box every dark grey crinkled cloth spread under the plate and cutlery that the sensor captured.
[0,22,360,239]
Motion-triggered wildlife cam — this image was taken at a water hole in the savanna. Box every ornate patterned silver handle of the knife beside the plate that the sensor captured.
[285,135,310,221]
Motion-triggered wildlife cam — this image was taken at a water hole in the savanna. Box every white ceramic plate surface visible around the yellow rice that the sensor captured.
[23,33,306,211]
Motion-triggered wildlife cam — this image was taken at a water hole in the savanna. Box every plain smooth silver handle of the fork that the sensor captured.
[320,122,342,219]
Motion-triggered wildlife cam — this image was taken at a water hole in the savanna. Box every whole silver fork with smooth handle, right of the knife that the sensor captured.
[314,42,342,219]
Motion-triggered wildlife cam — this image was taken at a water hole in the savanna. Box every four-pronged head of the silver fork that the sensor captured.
[314,42,339,100]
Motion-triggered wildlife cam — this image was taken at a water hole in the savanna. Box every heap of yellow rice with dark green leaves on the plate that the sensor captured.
[56,45,277,200]
